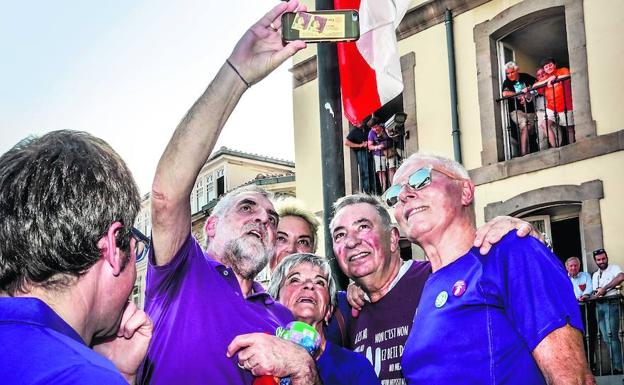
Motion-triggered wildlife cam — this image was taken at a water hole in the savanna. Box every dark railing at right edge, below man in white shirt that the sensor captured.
[579,295,624,377]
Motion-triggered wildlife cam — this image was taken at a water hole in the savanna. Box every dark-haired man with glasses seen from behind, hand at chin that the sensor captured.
[0,131,152,385]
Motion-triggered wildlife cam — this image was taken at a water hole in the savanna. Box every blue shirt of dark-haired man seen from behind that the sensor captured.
[0,297,128,385]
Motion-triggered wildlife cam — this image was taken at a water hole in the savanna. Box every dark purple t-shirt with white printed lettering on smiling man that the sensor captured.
[349,261,431,384]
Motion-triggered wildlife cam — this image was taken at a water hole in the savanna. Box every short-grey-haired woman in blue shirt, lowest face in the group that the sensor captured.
[268,254,380,385]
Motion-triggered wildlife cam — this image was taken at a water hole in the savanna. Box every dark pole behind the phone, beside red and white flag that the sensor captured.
[316,0,348,289]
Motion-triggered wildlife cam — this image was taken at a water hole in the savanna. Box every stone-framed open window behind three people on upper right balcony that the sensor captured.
[474,0,596,166]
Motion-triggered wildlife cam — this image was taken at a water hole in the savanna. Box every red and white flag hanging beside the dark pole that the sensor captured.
[334,0,410,124]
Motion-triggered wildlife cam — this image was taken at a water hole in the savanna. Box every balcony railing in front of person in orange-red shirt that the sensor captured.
[496,76,575,160]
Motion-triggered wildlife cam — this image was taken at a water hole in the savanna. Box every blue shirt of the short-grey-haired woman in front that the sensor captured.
[316,341,380,385]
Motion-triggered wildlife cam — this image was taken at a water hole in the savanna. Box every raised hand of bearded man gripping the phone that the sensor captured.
[228,0,307,85]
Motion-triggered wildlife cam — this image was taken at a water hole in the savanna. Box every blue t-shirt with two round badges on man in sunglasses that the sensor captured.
[402,232,583,385]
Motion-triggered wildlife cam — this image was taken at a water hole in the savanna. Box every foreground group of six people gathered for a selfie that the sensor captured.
[0,0,600,385]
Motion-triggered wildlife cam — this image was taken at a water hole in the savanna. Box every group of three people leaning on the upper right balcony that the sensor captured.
[502,58,576,156]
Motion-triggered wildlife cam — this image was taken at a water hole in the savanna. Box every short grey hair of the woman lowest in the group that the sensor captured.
[267,253,337,306]
